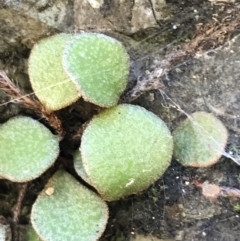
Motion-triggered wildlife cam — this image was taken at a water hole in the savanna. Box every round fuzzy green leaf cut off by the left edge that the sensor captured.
[0,117,59,182]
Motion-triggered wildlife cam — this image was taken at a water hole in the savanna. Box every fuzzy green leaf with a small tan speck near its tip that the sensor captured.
[31,171,108,241]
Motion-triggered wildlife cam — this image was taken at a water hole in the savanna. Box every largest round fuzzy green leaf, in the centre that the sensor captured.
[81,104,173,201]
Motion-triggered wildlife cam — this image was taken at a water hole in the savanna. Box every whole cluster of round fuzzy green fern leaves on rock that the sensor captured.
[0,33,227,241]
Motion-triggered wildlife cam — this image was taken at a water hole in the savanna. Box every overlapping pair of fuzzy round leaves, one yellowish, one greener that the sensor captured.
[29,33,129,111]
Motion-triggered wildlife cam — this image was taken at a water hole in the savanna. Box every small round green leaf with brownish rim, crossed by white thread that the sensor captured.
[173,112,228,167]
